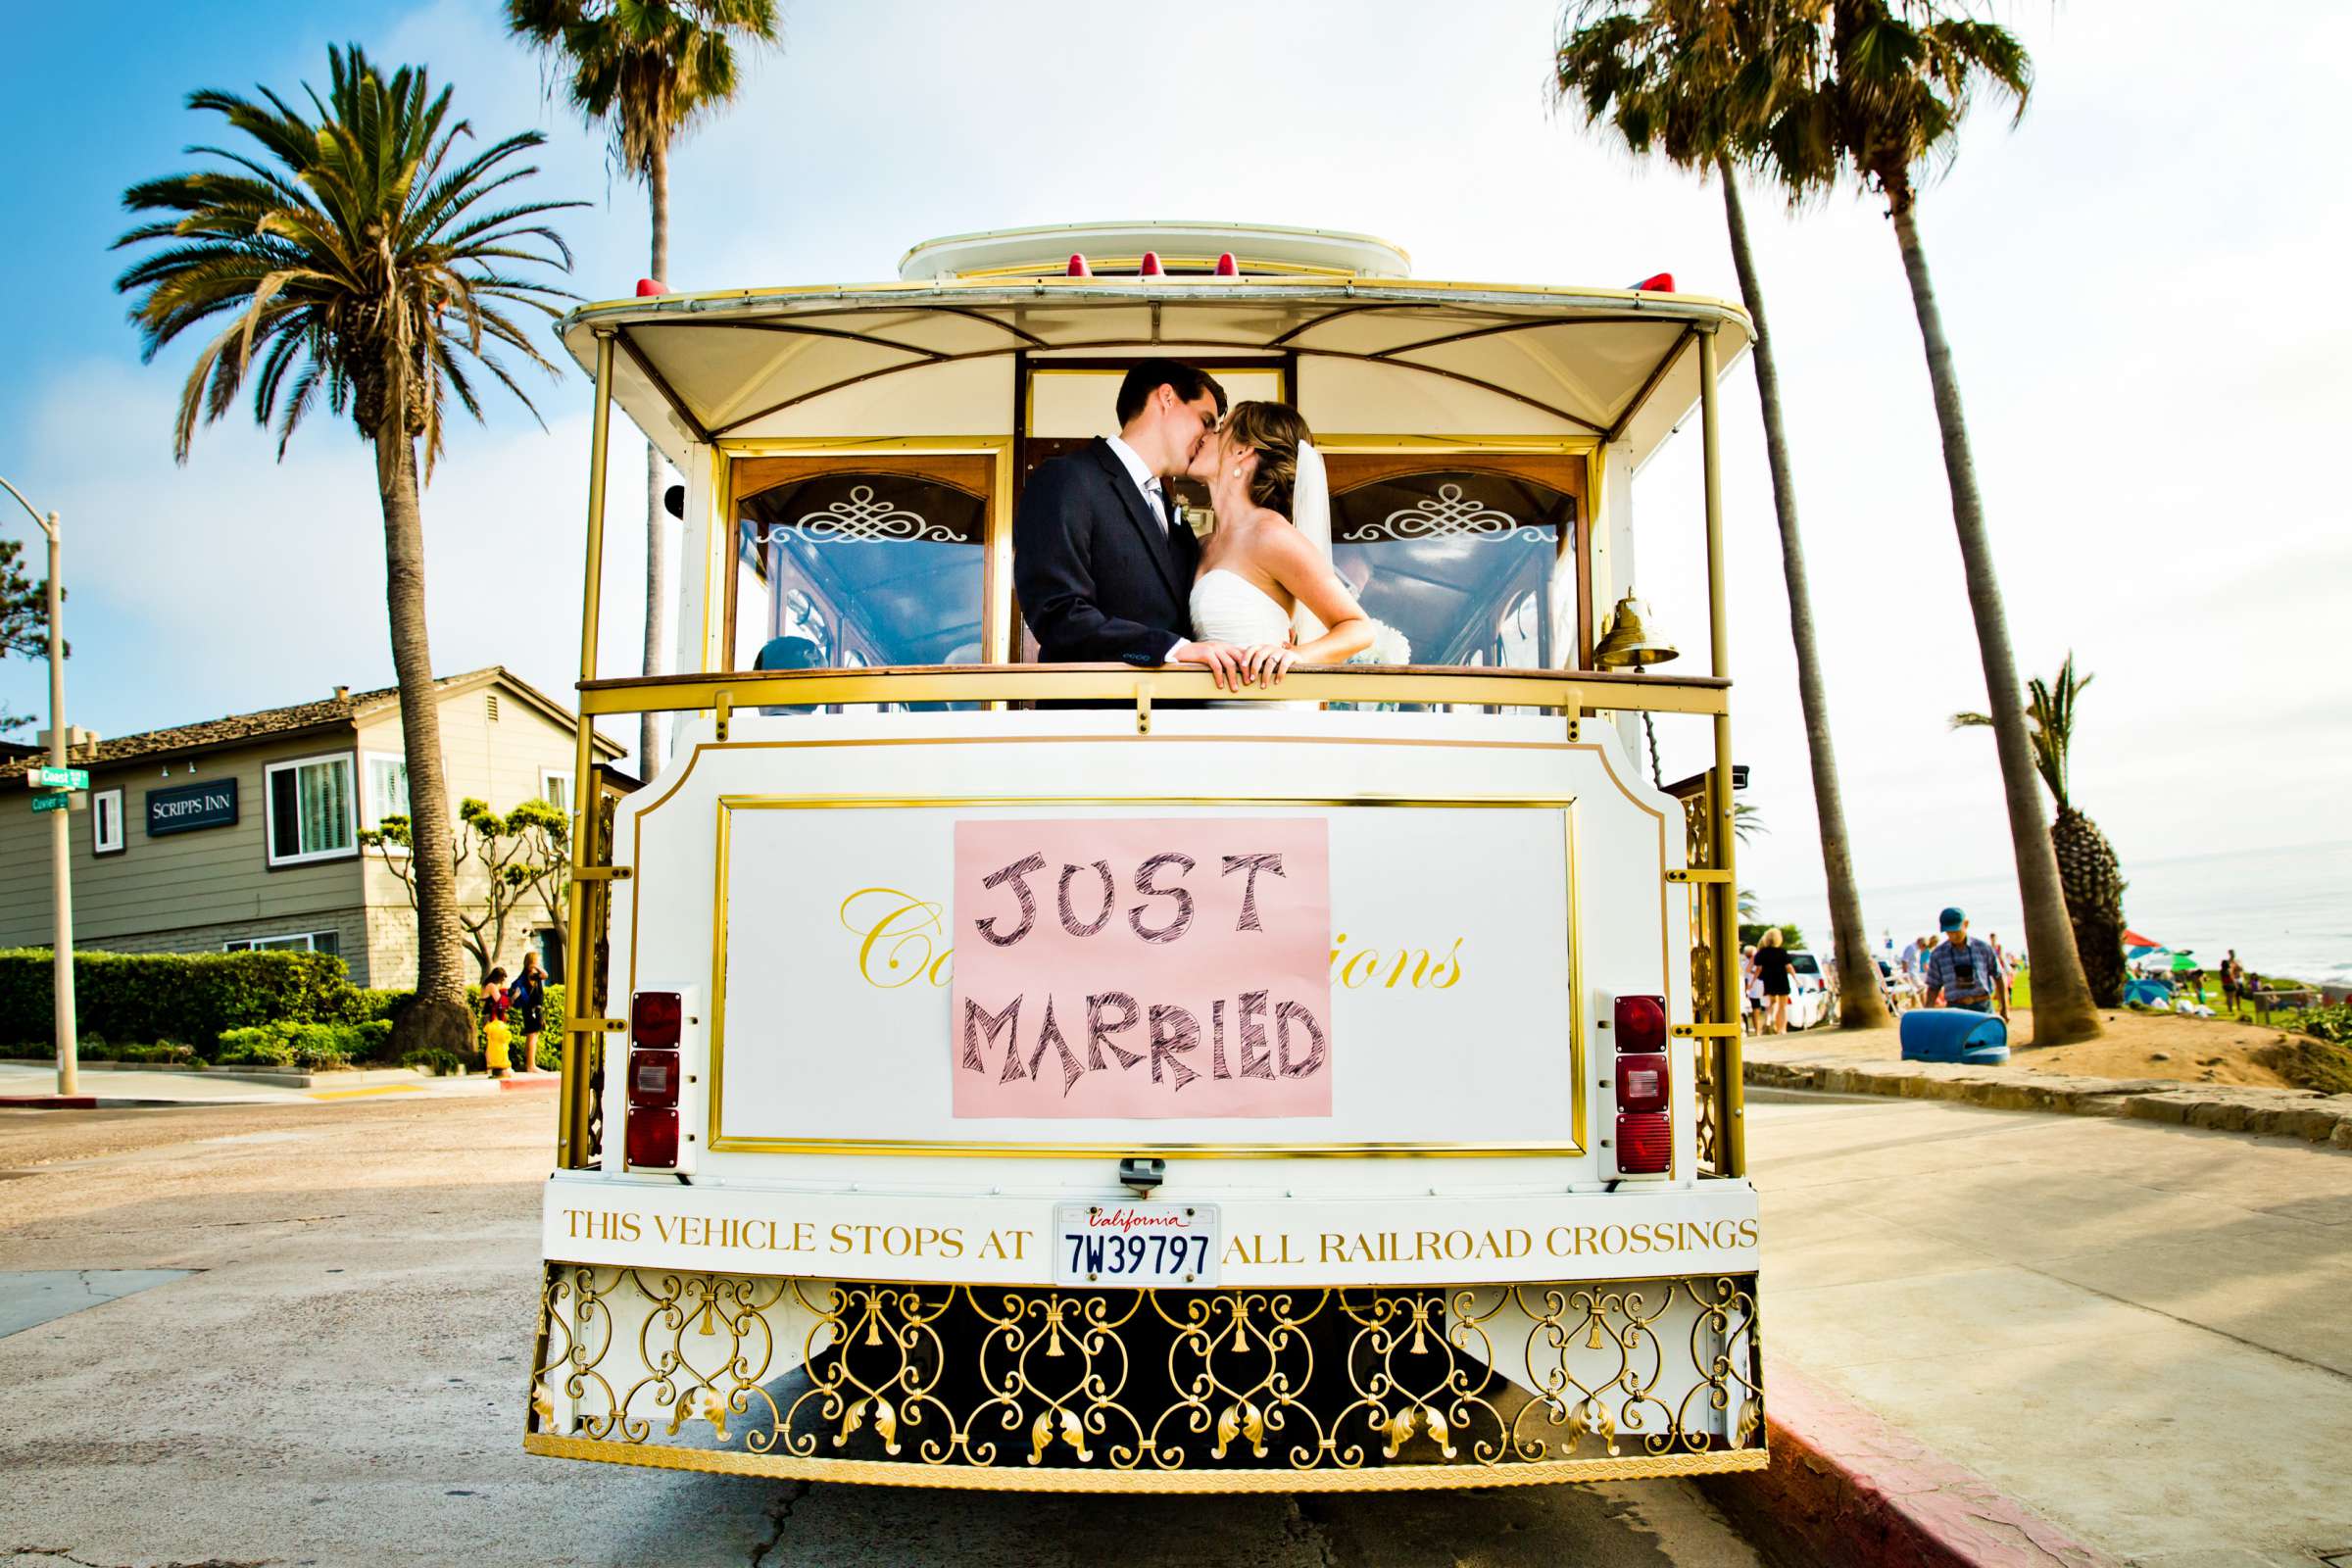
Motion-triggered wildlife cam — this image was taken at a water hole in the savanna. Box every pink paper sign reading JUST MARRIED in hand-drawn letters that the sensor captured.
[948,818,1331,1116]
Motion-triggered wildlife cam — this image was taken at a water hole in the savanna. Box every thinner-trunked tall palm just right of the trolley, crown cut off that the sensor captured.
[1554,0,1891,1030]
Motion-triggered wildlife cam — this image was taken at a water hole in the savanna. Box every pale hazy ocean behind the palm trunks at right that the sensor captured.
[1757,839,2352,985]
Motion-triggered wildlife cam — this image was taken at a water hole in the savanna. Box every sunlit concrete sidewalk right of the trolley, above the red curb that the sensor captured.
[1747,1089,2352,1568]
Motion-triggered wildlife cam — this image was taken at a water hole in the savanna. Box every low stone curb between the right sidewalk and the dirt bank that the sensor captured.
[1740,1055,2352,1150]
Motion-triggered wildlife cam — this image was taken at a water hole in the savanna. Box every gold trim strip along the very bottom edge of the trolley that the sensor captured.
[522,1432,1771,1495]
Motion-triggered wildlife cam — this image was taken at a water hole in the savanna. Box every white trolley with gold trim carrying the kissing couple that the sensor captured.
[524,223,1764,1491]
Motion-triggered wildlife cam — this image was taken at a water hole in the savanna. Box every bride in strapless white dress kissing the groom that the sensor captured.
[1181,402,1374,686]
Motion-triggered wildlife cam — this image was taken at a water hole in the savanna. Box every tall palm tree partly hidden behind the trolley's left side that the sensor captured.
[506,0,778,778]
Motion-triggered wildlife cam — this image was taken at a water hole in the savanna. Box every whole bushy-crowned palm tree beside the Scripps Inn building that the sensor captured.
[116,47,578,1051]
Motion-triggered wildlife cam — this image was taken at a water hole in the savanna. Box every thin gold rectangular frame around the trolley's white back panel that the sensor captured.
[706,795,1590,1159]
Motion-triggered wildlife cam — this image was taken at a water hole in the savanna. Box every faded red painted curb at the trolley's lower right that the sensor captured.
[1700,1363,2117,1568]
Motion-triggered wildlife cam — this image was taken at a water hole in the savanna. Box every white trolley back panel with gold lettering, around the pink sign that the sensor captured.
[712,797,1581,1152]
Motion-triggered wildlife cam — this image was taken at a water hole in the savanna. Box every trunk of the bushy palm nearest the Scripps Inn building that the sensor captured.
[376,416,472,1054]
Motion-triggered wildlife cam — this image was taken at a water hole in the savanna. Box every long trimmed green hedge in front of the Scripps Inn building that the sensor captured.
[0,948,353,1055]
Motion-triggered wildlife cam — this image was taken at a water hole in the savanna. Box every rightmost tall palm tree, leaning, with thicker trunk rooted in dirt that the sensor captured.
[1764,0,2100,1046]
